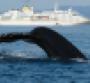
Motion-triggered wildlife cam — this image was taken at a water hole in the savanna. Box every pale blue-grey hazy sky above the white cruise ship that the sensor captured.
[0,0,90,11]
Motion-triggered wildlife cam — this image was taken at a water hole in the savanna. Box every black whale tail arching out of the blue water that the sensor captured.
[0,27,87,60]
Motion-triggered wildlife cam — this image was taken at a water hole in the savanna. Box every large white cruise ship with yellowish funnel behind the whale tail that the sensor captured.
[0,6,89,25]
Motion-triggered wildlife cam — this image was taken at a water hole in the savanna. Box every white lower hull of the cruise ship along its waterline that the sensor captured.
[0,20,89,26]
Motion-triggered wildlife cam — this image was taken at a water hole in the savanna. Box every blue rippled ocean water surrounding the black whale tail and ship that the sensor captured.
[0,7,90,83]
